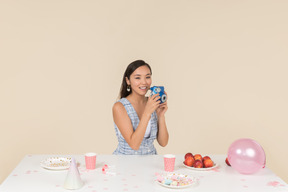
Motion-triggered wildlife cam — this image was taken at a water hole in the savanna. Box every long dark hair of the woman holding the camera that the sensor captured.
[120,60,152,99]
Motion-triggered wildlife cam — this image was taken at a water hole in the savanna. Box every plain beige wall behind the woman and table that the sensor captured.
[0,0,288,183]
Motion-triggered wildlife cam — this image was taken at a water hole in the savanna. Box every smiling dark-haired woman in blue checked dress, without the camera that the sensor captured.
[113,60,169,155]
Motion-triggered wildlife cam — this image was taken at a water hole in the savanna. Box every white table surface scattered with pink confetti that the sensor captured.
[0,155,288,192]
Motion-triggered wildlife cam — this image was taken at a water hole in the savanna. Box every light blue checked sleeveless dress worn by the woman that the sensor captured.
[113,98,158,155]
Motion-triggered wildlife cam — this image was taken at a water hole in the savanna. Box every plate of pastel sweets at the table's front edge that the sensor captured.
[155,173,197,189]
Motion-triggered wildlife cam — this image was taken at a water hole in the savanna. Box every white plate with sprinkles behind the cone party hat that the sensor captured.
[40,157,71,170]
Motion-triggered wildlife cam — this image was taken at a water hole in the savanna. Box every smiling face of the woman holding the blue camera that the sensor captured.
[126,65,152,95]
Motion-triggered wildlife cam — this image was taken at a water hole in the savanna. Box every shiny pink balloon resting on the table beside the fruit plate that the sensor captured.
[228,139,266,174]
